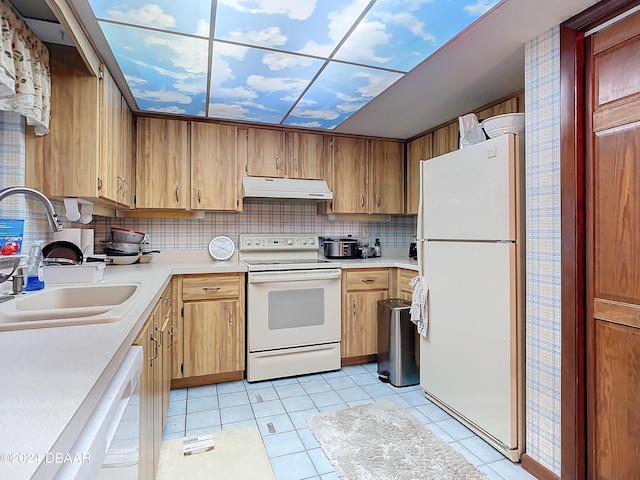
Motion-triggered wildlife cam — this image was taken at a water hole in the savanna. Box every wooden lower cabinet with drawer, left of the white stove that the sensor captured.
[171,273,245,387]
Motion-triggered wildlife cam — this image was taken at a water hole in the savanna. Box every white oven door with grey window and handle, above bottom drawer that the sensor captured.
[247,269,341,352]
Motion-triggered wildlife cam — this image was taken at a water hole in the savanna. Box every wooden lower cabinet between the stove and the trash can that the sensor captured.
[341,268,389,365]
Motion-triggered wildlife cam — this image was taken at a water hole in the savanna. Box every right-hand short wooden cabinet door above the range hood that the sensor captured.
[287,132,324,180]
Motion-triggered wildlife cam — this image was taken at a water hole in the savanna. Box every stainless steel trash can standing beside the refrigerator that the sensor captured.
[378,298,420,387]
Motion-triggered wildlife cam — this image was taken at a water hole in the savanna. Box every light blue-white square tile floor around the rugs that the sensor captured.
[163,363,535,480]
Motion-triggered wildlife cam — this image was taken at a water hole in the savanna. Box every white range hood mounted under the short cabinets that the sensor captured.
[242,177,333,202]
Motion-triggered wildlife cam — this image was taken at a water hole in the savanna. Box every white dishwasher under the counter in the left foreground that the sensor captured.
[55,346,143,480]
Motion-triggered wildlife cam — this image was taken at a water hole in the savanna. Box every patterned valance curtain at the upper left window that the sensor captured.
[0,0,51,135]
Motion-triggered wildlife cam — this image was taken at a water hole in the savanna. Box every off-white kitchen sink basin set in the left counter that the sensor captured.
[0,283,140,331]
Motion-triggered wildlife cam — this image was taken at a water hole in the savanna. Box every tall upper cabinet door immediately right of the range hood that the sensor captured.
[331,137,369,213]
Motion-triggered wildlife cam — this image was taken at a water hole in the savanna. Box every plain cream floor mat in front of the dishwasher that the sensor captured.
[156,426,274,480]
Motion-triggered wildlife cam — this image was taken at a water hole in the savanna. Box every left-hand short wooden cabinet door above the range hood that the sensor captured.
[246,128,285,177]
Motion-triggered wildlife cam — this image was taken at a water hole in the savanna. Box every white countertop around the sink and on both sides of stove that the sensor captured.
[0,251,418,480]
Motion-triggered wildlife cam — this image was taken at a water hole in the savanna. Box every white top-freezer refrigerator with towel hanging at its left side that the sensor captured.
[417,134,524,461]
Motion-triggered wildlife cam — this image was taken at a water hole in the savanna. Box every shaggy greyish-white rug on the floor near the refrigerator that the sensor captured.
[308,401,488,480]
